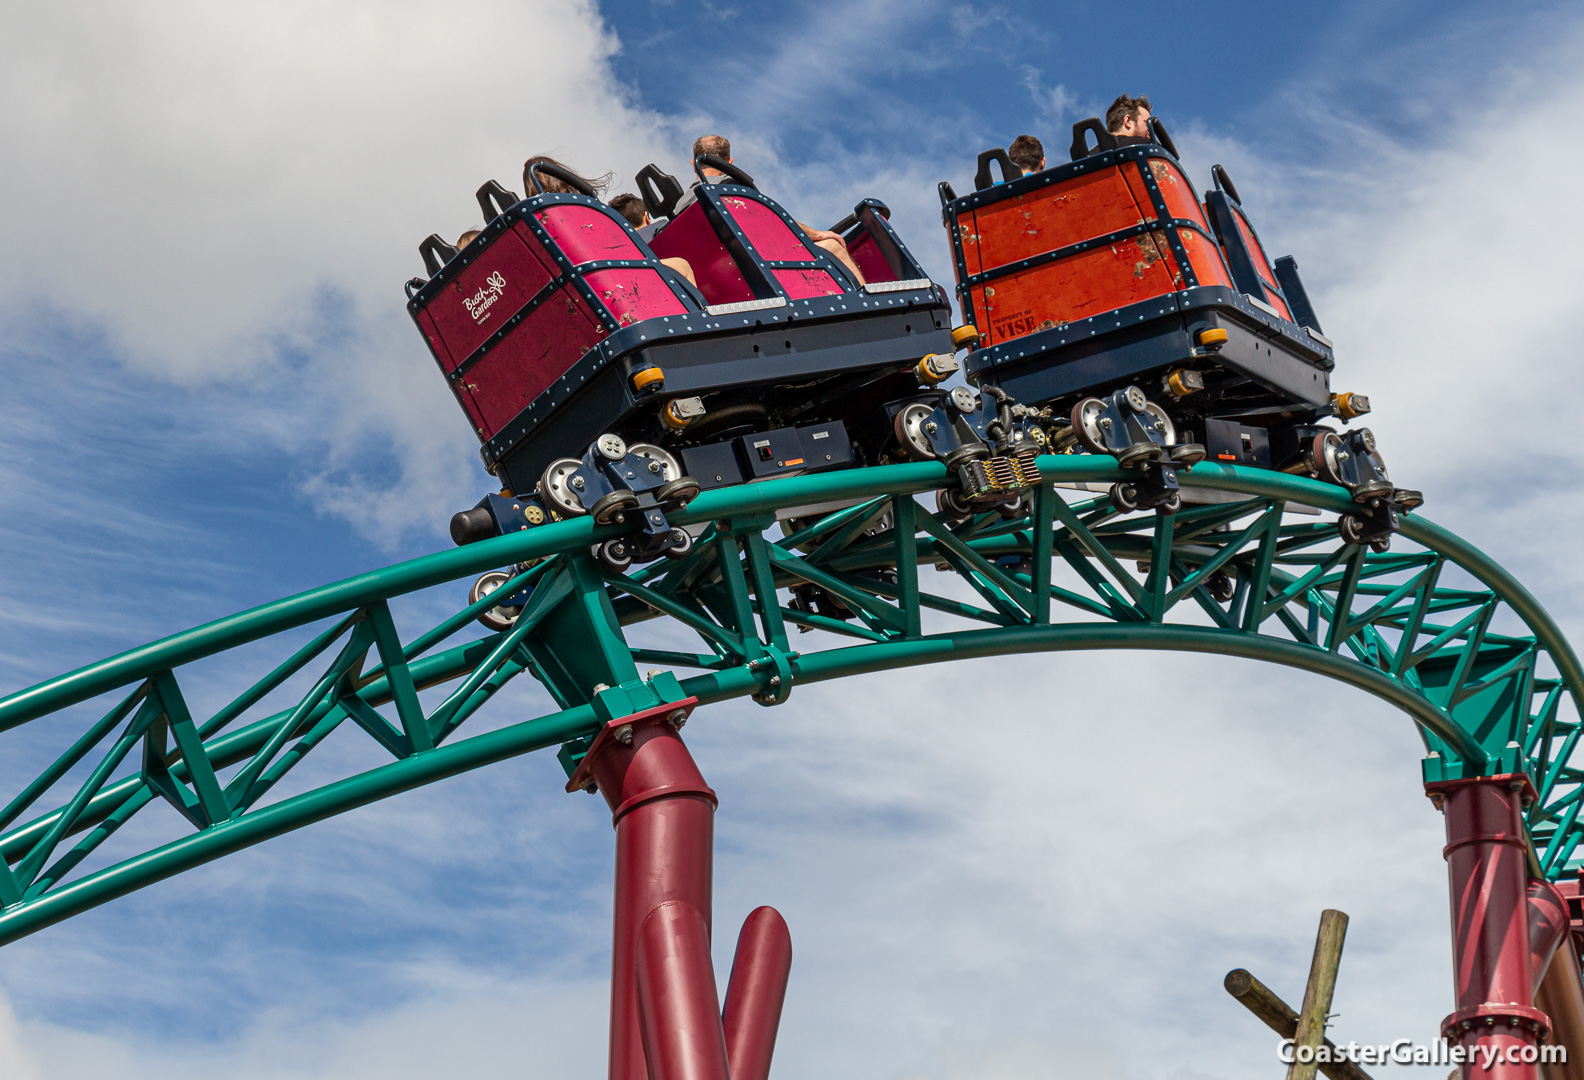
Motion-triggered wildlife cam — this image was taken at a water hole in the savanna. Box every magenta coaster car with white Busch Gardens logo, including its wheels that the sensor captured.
[409,157,988,585]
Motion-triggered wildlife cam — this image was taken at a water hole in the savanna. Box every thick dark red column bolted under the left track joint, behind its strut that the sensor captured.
[567,698,724,1080]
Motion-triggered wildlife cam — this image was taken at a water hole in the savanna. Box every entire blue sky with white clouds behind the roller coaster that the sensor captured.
[0,0,1584,1080]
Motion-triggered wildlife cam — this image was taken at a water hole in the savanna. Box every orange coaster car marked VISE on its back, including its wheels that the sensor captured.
[939,120,1422,546]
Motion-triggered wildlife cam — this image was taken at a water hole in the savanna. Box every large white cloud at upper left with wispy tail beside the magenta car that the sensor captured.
[0,0,693,540]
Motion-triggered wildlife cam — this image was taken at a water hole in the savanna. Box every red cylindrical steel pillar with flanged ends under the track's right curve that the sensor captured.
[1426,773,1551,1080]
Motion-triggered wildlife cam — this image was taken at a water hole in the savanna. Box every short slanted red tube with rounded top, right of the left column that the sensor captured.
[722,907,792,1080]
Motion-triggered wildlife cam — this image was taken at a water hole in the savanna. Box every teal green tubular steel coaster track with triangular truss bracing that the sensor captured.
[0,456,1584,944]
